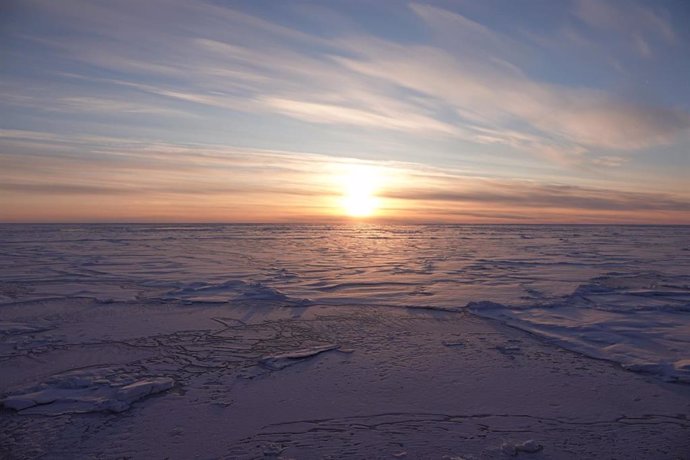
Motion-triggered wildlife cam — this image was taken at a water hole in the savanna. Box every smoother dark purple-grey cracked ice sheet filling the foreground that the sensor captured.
[0,299,690,459]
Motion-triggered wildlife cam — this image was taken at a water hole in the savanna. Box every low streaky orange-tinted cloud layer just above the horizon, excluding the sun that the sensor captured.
[0,131,690,222]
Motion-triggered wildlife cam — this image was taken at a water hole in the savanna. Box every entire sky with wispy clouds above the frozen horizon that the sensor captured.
[0,0,690,224]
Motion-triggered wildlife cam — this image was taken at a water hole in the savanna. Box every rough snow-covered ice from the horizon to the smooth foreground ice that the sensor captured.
[0,225,690,381]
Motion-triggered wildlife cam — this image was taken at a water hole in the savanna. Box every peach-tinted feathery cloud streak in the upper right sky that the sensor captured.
[341,5,690,150]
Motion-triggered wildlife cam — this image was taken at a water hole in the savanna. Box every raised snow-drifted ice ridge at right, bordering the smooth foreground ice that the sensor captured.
[468,273,690,383]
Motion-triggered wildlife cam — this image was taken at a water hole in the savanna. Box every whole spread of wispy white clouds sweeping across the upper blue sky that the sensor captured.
[4,0,690,163]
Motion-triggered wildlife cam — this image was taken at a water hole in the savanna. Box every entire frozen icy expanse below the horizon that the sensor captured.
[0,225,690,459]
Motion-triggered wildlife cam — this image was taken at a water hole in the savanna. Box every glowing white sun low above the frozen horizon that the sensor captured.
[341,165,380,217]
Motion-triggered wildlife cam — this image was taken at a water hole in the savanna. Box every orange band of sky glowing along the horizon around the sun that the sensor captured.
[0,136,690,224]
